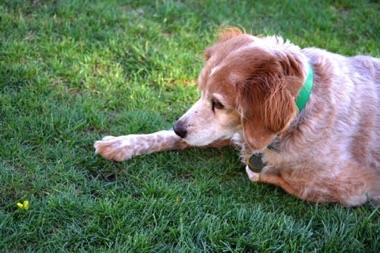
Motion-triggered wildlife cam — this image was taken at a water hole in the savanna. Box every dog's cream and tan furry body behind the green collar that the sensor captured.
[272,48,380,205]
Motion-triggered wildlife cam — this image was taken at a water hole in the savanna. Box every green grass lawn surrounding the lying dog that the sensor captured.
[0,0,380,252]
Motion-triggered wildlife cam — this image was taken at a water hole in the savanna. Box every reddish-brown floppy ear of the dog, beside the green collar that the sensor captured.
[236,52,302,151]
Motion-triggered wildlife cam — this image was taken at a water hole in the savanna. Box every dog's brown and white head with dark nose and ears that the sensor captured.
[174,29,307,151]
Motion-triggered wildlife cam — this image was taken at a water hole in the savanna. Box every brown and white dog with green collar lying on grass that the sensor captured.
[94,28,380,206]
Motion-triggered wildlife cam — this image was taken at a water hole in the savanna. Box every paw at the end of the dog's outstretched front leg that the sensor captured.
[94,136,135,162]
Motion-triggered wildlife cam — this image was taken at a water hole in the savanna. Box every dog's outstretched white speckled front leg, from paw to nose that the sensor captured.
[94,130,189,162]
